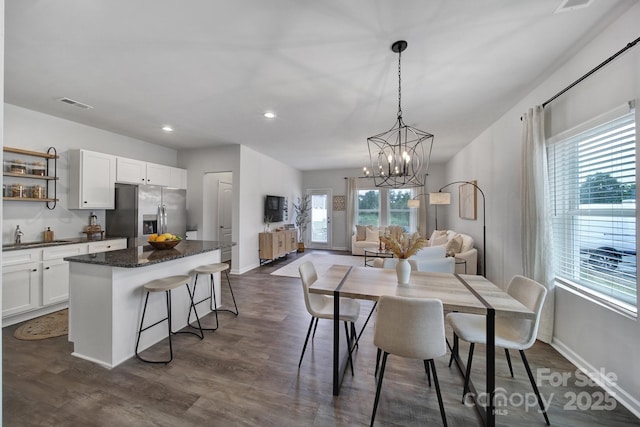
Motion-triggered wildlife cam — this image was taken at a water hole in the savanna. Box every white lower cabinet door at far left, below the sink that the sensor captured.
[2,262,41,318]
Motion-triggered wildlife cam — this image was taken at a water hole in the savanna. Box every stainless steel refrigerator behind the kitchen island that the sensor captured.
[106,184,187,248]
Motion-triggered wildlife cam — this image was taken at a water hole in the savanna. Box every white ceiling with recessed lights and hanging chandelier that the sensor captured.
[5,0,635,170]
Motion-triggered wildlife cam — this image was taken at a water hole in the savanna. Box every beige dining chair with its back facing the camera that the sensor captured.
[371,296,447,426]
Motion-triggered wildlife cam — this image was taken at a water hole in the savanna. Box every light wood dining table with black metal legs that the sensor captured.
[309,265,535,427]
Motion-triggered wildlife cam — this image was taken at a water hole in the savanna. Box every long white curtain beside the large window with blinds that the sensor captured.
[522,106,555,343]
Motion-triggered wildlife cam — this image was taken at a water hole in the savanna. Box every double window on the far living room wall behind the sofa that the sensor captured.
[356,188,417,232]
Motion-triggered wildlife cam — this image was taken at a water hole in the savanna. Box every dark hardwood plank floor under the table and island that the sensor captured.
[3,251,640,427]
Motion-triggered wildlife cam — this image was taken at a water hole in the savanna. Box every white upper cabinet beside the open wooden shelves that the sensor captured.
[69,150,116,209]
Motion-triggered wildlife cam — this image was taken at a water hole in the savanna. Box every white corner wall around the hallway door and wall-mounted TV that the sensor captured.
[178,145,302,274]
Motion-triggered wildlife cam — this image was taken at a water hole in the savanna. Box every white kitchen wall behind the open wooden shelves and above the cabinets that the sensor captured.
[2,103,177,243]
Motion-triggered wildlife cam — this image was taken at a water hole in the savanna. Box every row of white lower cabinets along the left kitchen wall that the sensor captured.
[2,239,127,326]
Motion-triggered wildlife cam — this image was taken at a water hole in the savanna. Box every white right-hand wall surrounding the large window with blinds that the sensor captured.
[438,4,640,416]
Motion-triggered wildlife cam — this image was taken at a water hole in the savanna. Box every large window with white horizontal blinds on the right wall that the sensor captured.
[547,110,637,312]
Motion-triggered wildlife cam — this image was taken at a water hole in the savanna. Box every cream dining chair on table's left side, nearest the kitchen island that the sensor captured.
[298,261,360,374]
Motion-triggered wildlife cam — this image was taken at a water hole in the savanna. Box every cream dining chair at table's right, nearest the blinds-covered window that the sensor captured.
[447,276,549,425]
